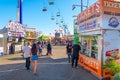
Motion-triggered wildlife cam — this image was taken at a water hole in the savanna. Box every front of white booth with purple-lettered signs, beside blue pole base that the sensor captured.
[6,20,25,54]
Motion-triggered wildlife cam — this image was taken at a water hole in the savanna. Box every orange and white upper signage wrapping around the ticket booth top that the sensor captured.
[77,0,120,32]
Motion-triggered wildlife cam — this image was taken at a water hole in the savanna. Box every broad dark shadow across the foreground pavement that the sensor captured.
[0,56,98,80]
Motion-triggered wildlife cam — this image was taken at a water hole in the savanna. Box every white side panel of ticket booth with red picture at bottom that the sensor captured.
[103,30,120,62]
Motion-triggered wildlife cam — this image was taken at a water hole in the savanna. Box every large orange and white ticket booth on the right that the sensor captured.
[77,0,120,80]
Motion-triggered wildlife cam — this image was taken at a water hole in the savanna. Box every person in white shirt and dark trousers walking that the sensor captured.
[23,42,31,70]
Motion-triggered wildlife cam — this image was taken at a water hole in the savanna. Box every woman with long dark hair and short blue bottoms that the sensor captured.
[31,43,38,75]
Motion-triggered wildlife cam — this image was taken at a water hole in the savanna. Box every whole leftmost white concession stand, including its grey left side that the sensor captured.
[0,20,25,54]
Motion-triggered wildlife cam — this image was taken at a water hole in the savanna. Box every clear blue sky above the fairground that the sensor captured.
[0,0,97,34]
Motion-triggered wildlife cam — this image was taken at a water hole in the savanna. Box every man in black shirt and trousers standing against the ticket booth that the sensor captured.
[72,42,81,68]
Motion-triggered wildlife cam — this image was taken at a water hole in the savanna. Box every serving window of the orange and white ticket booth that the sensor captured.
[81,36,98,59]
